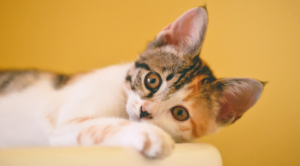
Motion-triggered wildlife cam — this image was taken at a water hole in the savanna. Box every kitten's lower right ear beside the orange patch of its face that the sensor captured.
[212,78,265,126]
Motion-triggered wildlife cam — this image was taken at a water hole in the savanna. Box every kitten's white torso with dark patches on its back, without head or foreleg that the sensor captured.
[0,64,132,147]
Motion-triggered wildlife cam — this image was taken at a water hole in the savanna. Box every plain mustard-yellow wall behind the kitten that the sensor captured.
[0,0,300,166]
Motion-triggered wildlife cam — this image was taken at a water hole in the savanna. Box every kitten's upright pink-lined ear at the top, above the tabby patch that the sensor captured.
[149,7,207,55]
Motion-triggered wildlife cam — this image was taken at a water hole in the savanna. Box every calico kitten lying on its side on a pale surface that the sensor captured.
[0,7,264,158]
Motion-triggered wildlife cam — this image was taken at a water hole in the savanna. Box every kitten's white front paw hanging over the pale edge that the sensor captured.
[121,123,175,158]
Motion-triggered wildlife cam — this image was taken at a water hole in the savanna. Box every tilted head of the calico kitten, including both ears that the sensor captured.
[126,7,263,142]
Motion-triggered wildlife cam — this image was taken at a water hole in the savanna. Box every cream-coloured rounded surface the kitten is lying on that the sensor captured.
[0,143,222,166]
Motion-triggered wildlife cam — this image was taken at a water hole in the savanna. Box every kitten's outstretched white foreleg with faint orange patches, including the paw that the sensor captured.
[50,118,174,158]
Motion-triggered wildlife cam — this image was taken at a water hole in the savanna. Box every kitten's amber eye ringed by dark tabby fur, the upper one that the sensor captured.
[144,71,161,92]
